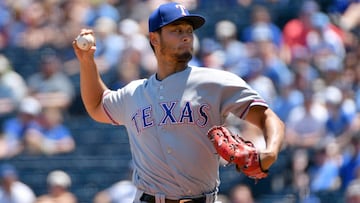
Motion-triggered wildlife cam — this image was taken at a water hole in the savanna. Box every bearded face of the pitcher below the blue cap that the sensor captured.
[159,21,194,62]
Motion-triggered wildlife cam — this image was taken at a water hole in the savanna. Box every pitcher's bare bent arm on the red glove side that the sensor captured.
[245,105,285,170]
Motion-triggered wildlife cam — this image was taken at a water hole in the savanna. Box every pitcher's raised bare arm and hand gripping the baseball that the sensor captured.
[73,29,112,123]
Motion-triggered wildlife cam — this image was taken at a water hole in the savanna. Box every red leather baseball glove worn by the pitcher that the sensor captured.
[207,126,268,180]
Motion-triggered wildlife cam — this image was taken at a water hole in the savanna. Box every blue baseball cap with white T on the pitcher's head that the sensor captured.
[149,2,205,32]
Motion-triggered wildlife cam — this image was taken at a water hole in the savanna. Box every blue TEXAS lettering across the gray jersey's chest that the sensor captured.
[131,101,210,133]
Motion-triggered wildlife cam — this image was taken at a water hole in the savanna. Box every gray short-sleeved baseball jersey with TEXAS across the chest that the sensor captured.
[103,67,267,199]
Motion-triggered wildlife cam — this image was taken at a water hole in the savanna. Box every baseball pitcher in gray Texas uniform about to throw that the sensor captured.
[73,2,284,203]
